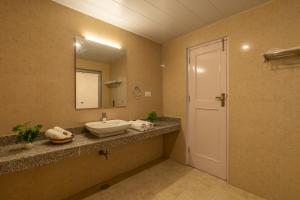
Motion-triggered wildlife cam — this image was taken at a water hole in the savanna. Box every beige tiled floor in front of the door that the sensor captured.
[85,160,263,200]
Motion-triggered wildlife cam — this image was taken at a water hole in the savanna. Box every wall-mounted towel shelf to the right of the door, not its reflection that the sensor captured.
[263,47,300,62]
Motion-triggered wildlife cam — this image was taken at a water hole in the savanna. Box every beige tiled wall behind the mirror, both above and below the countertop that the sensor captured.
[0,0,163,200]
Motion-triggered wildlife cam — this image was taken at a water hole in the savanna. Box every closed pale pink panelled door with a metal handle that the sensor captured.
[188,39,227,179]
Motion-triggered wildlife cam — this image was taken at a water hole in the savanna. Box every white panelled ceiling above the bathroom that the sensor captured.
[53,0,268,43]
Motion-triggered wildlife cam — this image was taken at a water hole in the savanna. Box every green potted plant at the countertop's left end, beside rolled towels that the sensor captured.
[12,122,43,149]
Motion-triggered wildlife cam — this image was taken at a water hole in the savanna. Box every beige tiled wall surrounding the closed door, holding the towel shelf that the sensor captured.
[162,0,300,200]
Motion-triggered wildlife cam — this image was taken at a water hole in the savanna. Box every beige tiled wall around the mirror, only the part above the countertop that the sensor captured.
[0,0,162,135]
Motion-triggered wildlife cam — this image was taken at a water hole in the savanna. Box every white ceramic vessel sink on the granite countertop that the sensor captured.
[85,120,130,137]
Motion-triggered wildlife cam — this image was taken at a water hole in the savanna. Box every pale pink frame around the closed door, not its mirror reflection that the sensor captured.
[185,36,230,182]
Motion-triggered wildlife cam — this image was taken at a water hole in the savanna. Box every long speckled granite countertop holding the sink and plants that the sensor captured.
[0,118,181,175]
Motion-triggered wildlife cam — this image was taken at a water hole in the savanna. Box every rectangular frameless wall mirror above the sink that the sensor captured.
[75,36,127,109]
